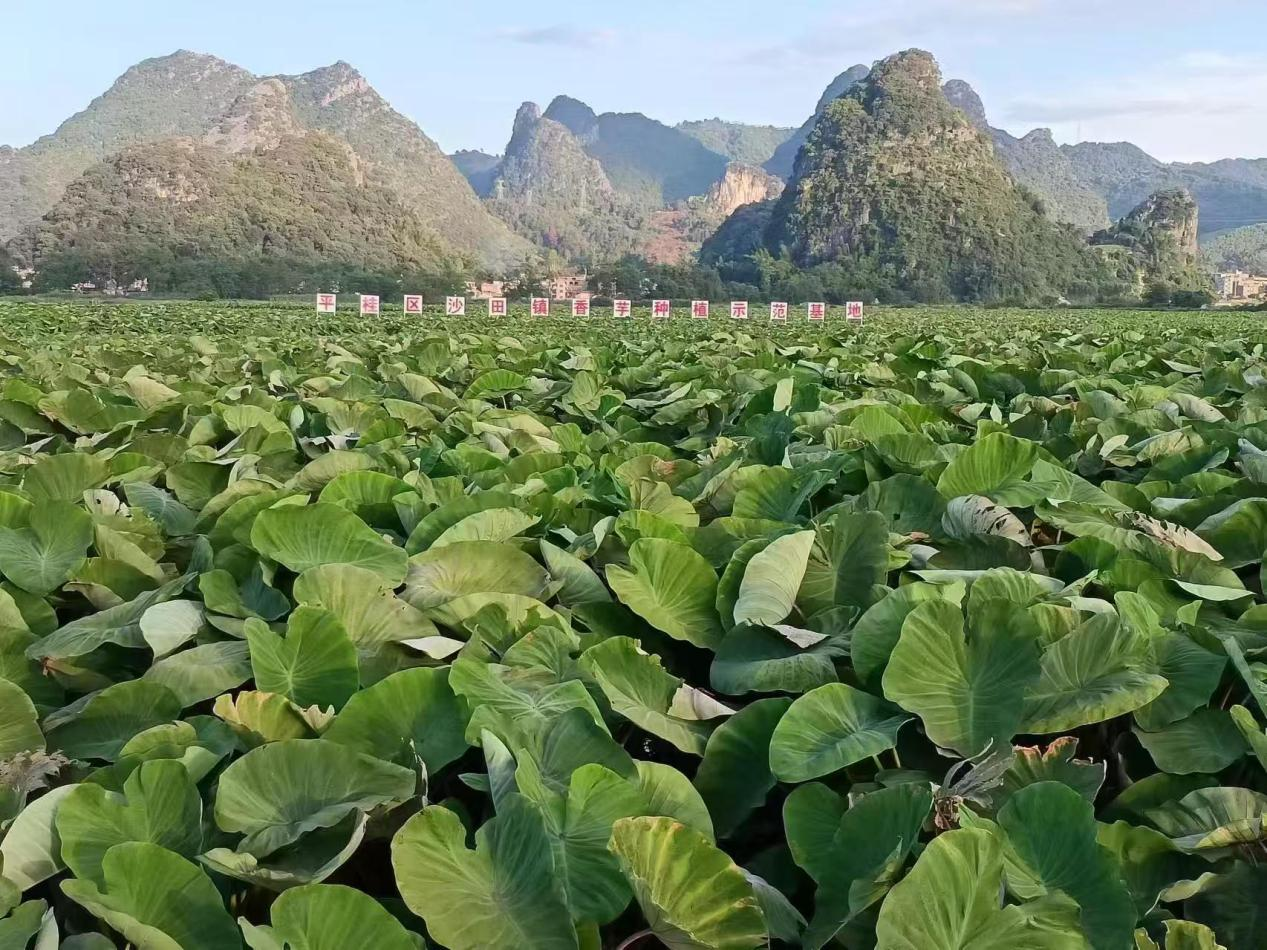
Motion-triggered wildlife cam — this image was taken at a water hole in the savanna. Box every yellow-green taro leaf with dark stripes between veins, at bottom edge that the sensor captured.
[611,817,767,950]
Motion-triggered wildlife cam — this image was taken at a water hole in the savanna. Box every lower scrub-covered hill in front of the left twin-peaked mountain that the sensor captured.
[15,133,468,296]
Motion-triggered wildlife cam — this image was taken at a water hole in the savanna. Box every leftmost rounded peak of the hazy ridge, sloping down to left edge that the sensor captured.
[0,49,256,242]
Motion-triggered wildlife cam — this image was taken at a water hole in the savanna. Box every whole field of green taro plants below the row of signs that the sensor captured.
[0,303,1267,950]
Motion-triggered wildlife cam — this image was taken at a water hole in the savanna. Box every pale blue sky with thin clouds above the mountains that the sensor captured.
[9,0,1267,161]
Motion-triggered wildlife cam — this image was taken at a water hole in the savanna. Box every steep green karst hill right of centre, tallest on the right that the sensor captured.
[764,51,1104,300]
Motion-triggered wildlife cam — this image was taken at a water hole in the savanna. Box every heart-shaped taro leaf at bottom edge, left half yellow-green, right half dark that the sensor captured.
[392,795,579,950]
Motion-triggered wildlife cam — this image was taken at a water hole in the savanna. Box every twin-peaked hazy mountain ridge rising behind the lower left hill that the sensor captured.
[0,52,528,267]
